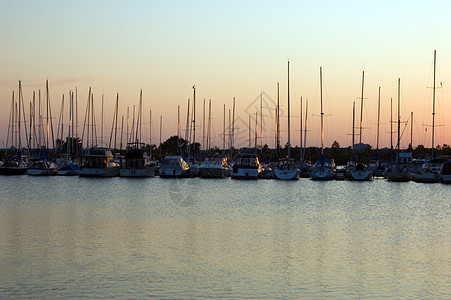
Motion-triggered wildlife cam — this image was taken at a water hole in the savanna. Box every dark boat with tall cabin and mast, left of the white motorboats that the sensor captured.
[120,90,156,177]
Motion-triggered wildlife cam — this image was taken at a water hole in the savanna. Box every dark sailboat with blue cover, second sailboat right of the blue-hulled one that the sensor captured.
[385,78,412,182]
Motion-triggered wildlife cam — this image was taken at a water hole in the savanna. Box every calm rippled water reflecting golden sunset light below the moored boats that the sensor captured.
[0,176,451,299]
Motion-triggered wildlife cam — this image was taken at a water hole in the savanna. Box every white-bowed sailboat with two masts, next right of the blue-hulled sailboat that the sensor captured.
[346,72,373,181]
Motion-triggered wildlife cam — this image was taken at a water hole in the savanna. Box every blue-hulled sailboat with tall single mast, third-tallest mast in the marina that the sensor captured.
[310,67,335,180]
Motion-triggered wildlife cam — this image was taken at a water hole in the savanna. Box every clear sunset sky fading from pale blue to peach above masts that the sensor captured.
[0,0,451,148]
